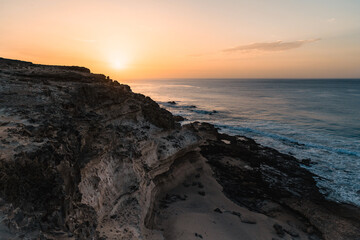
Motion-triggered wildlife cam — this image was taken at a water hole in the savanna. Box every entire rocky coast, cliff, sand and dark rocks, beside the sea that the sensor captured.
[0,58,360,240]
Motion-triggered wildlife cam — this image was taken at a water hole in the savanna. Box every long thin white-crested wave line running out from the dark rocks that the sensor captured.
[216,124,360,157]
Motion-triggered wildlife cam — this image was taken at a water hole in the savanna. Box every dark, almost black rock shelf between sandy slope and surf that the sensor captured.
[193,123,360,239]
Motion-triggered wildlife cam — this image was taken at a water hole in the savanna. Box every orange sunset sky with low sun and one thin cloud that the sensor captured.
[0,0,360,80]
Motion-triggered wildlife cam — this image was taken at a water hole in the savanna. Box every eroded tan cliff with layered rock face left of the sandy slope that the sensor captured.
[0,59,198,239]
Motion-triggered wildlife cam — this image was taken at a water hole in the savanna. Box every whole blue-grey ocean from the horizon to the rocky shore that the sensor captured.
[127,79,360,206]
